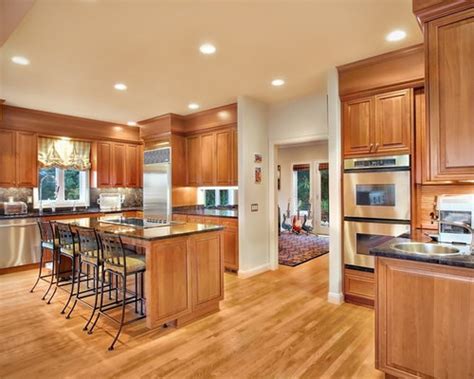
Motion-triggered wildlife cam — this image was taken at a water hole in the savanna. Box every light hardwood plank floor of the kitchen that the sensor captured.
[0,255,382,378]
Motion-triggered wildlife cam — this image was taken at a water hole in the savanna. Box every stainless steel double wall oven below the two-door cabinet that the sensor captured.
[344,155,410,270]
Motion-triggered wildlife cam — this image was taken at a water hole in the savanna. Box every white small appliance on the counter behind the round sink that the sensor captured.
[436,194,474,244]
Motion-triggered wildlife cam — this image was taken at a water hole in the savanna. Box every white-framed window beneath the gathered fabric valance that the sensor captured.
[33,167,90,208]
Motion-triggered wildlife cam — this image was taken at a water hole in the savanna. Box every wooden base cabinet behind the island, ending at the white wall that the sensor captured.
[173,214,239,271]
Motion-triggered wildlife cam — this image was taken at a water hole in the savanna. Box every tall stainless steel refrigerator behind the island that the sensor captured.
[143,145,171,220]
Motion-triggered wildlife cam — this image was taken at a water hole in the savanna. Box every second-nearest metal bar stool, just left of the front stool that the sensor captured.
[66,227,103,330]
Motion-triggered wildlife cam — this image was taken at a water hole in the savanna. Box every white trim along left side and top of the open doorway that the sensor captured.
[268,134,328,270]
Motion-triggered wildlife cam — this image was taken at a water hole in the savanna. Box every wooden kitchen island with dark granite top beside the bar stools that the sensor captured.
[57,217,224,329]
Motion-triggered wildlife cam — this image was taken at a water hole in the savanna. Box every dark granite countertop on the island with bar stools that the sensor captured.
[57,217,224,241]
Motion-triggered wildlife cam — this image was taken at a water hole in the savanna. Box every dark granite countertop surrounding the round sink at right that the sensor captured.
[369,229,474,269]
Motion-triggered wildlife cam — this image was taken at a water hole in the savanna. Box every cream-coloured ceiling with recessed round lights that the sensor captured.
[0,0,422,123]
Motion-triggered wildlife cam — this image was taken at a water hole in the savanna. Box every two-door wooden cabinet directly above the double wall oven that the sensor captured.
[343,89,413,156]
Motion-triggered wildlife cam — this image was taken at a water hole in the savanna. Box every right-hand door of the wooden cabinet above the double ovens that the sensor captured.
[373,89,413,153]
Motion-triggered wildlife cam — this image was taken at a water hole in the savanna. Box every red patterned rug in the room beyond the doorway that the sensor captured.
[278,233,329,267]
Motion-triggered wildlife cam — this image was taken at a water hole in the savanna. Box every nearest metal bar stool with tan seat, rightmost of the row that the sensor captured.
[89,232,146,350]
